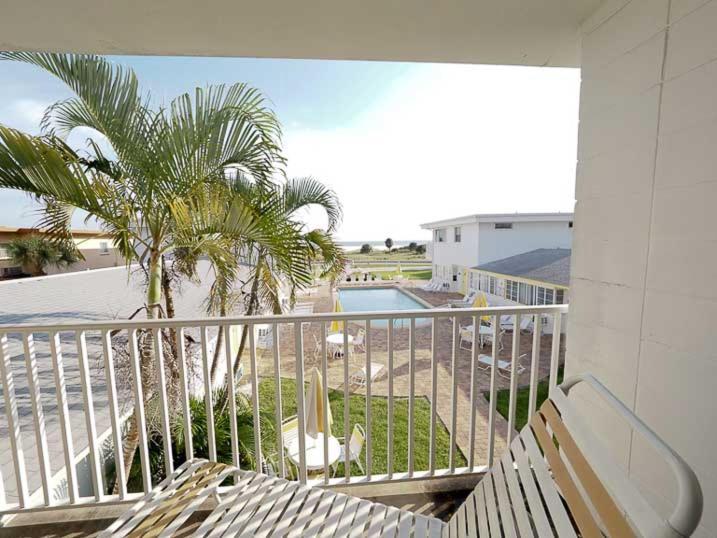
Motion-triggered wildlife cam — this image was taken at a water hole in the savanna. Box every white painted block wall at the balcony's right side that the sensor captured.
[567,0,717,537]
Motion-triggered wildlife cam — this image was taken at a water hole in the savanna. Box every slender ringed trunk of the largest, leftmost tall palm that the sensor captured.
[113,251,162,493]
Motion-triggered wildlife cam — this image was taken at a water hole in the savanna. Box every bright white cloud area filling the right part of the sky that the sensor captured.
[285,62,579,239]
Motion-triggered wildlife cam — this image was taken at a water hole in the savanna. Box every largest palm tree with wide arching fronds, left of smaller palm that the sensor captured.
[0,52,292,486]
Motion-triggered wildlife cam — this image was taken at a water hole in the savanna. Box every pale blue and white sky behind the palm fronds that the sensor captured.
[0,56,580,241]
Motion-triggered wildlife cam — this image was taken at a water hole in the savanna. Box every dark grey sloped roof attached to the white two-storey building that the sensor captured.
[473,248,570,287]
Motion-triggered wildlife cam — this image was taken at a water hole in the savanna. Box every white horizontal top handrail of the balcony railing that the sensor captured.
[0,304,568,333]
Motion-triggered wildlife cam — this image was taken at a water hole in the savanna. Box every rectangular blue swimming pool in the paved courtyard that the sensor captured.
[339,288,431,328]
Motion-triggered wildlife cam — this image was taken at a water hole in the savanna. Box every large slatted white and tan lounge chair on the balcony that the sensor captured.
[102,374,703,538]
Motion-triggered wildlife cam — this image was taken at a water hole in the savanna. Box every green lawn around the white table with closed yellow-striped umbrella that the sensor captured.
[259,379,466,476]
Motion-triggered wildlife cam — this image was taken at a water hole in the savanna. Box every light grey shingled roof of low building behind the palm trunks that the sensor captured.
[0,262,221,502]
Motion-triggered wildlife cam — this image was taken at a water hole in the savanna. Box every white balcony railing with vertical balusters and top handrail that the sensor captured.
[0,305,569,514]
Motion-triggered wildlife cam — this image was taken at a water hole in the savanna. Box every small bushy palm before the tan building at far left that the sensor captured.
[7,235,81,276]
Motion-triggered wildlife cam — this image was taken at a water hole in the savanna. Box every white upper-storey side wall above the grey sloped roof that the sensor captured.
[473,221,573,266]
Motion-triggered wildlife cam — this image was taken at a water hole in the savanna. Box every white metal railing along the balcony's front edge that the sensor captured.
[0,305,568,513]
